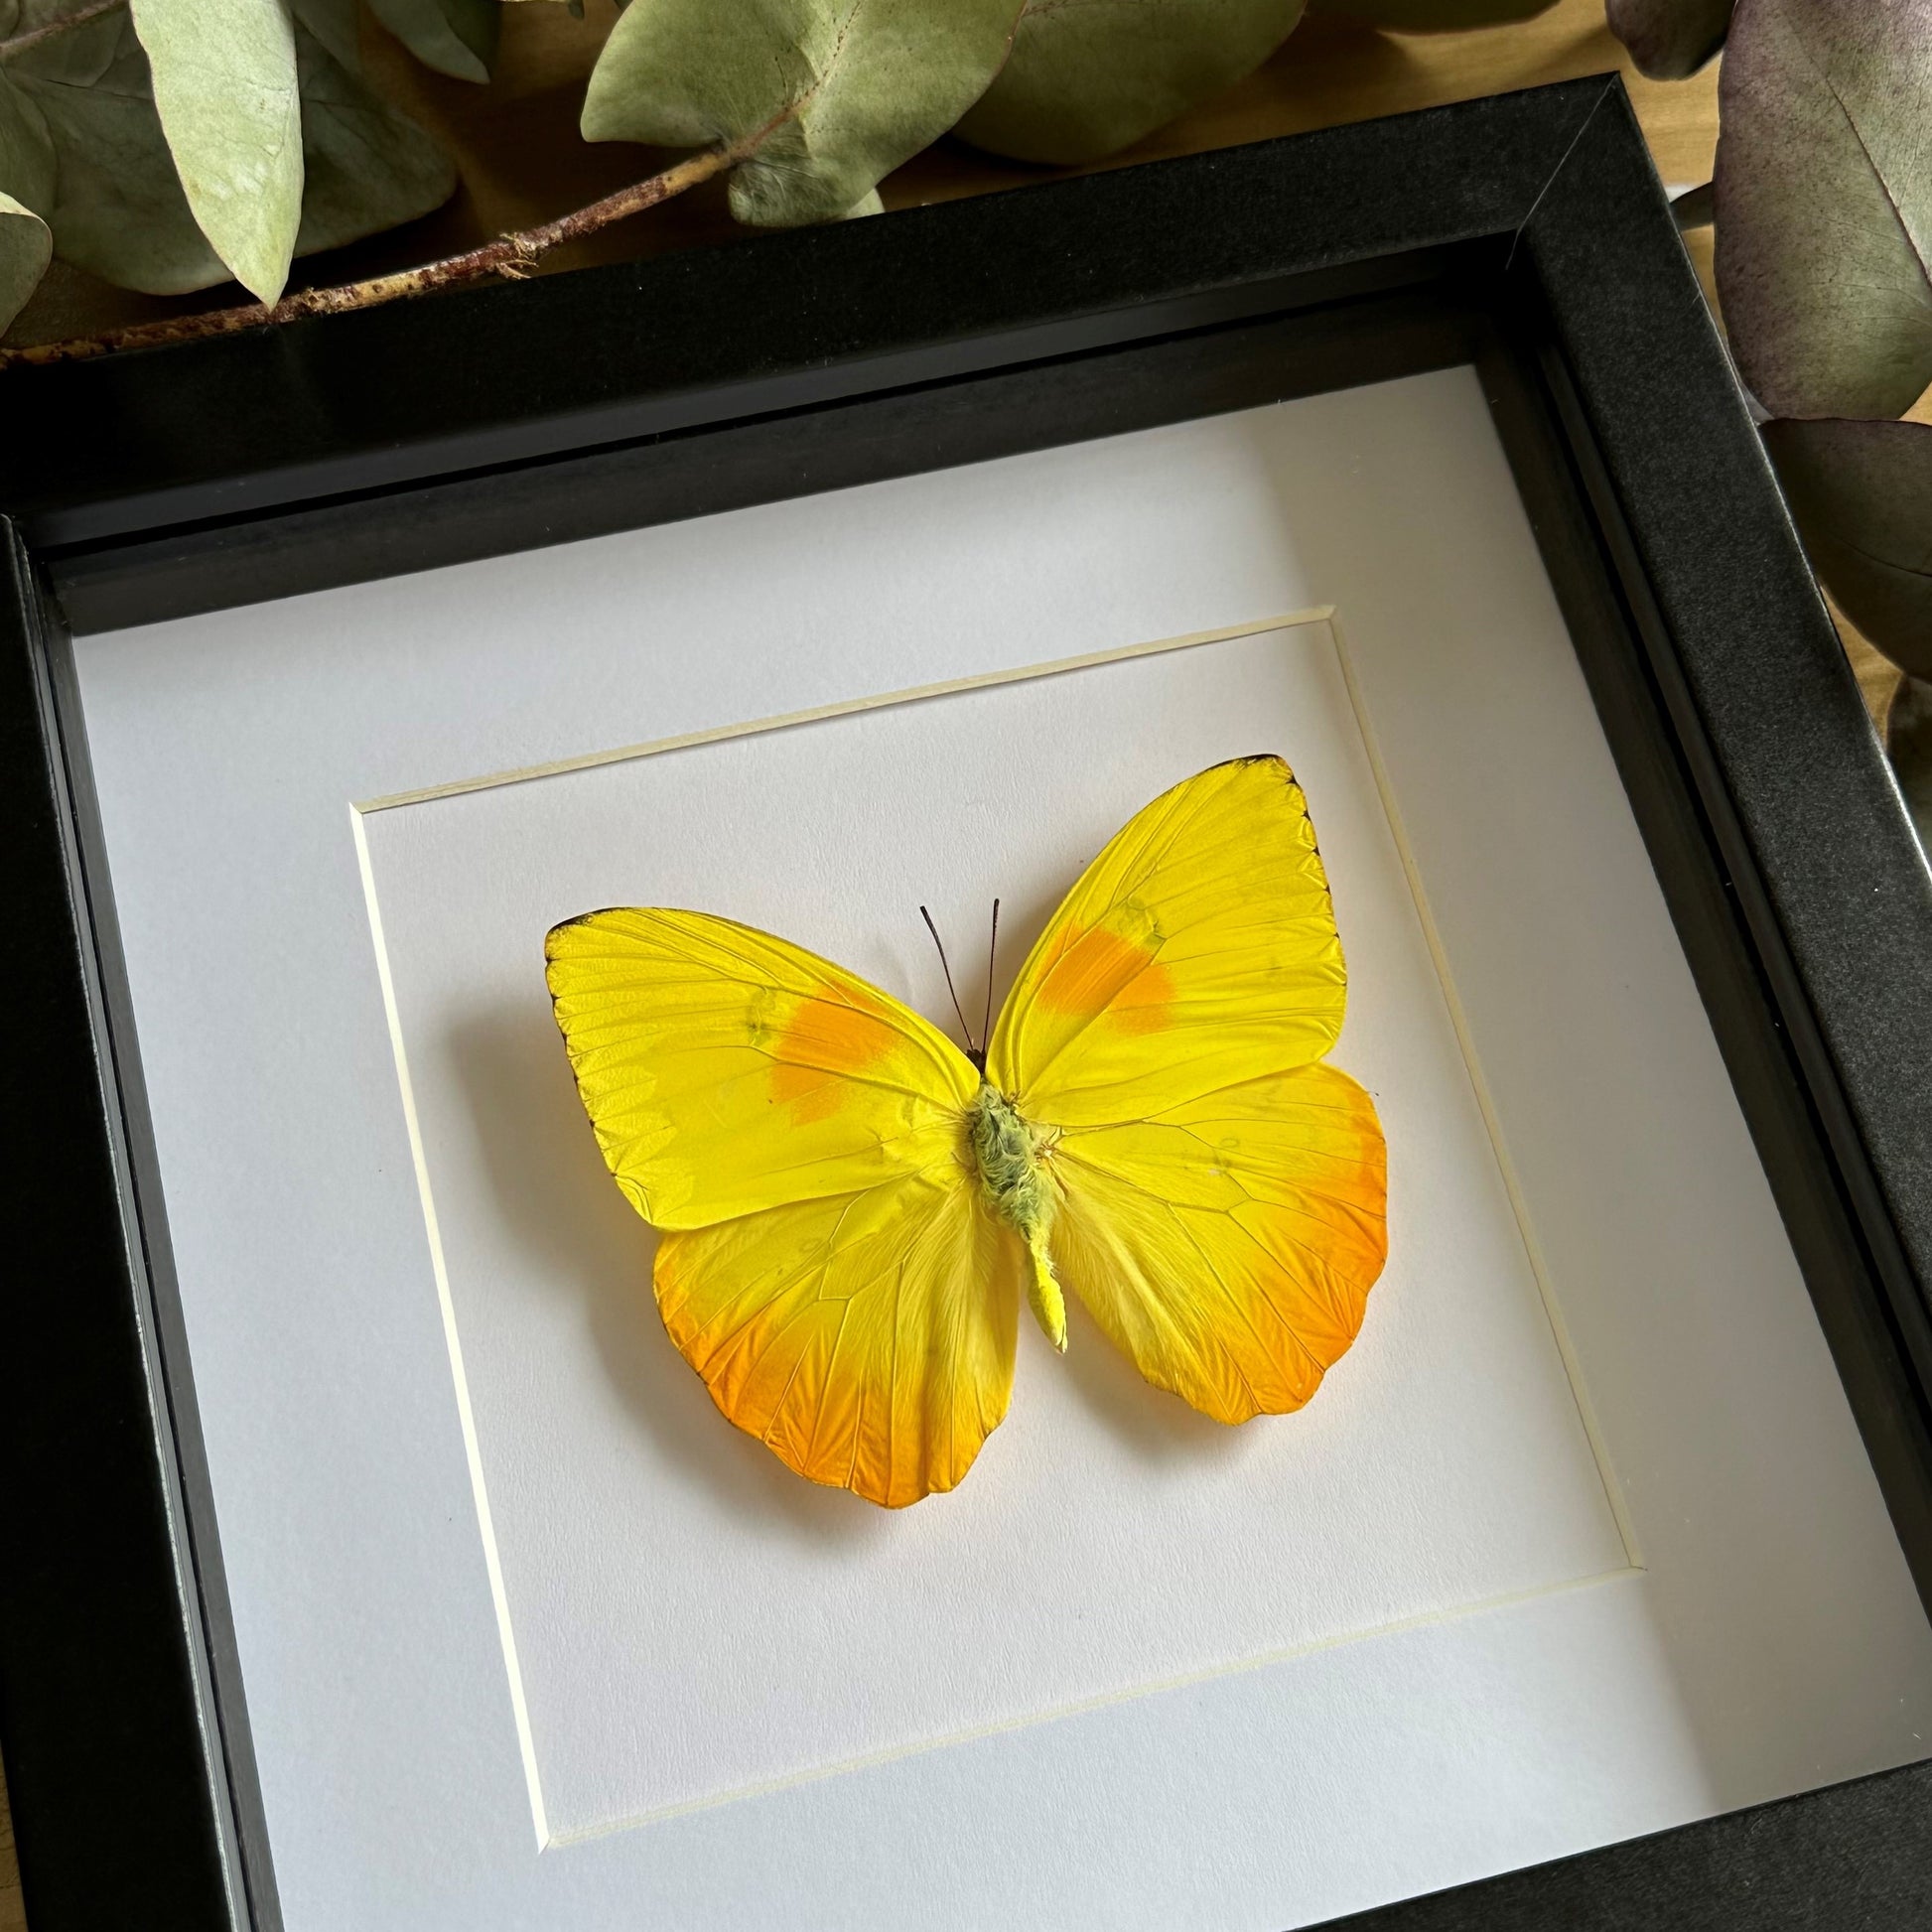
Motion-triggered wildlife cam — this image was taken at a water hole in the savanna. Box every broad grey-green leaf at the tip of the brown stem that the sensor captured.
[584,0,1020,228]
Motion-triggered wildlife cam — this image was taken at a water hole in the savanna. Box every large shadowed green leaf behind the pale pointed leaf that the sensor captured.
[6,0,456,296]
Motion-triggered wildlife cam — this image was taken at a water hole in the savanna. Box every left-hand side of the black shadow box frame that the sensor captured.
[0,519,280,1932]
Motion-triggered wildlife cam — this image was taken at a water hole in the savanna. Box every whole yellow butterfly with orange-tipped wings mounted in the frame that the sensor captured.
[545,758,1387,1507]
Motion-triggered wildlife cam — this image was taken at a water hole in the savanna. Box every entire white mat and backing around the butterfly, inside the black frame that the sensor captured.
[77,371,1932,1932]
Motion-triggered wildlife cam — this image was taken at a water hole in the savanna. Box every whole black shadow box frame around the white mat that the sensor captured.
[0,79,1932,1932]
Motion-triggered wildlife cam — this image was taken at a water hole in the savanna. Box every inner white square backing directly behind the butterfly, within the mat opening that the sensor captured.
[363,622,1627,1840]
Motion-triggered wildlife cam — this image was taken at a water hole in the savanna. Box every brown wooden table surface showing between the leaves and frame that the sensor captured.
[0,0,1895,1932]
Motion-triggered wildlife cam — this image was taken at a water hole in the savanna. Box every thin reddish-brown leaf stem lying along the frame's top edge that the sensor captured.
[0,134,782,369]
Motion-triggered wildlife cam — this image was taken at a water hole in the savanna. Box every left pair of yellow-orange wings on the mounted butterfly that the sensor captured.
[545,908,1019,1505]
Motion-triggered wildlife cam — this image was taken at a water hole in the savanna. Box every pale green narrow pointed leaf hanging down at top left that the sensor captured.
[131,0,302,302]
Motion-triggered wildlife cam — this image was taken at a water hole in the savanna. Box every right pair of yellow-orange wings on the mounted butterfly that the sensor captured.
[987,758,1387,1422]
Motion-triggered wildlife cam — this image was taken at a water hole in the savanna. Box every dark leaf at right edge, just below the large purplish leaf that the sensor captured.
[1764,419,1932,678]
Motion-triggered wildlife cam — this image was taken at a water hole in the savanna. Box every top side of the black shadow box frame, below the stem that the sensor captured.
[0,77,1605,551]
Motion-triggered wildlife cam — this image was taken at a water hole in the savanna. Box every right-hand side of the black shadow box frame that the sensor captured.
[1524,87,1932,1609]
